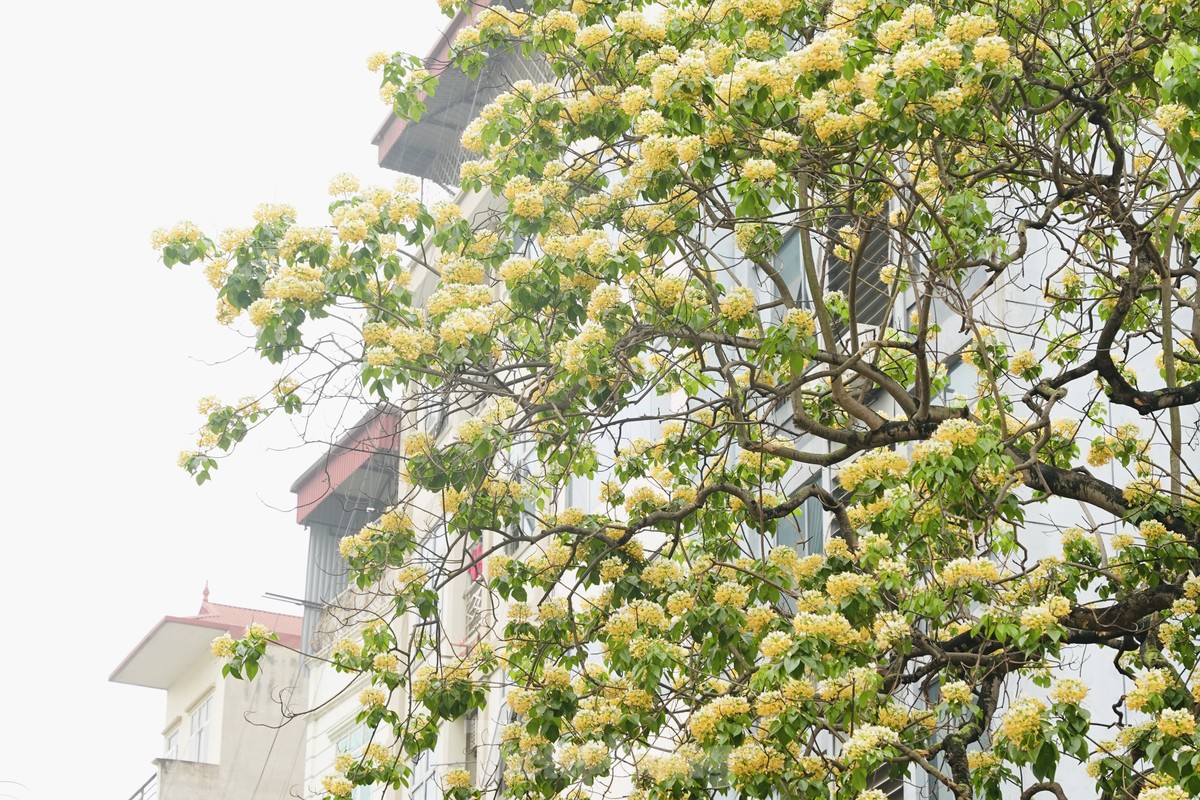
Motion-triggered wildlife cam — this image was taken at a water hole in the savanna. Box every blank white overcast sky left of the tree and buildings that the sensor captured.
[0,0,445,800]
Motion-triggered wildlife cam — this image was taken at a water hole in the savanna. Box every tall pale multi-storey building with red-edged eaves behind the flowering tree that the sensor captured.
[280,6,1190,800]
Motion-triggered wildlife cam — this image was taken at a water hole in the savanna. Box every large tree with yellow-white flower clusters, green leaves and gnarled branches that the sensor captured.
[164,0,1200,800]
